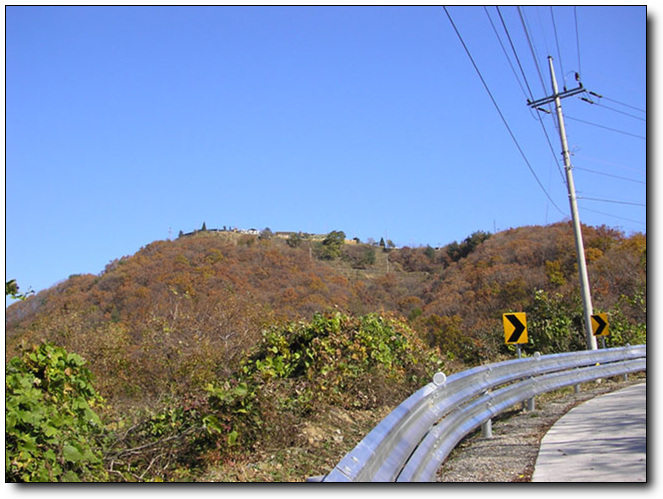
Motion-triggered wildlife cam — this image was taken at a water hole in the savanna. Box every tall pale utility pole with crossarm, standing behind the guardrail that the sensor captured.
[528,56,597,350]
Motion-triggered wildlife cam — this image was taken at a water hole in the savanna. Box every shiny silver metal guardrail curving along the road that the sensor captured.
[322,345,647,482]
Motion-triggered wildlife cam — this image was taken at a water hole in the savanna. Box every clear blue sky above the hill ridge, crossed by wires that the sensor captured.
[5,6,647,300]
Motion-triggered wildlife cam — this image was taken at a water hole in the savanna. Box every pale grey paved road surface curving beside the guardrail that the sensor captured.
[532,383,647,482]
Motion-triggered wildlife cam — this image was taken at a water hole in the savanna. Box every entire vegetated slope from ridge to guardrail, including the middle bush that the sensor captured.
[5,223,647,481]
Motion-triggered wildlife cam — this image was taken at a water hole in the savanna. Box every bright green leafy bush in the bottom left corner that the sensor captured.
[5,343,107,482]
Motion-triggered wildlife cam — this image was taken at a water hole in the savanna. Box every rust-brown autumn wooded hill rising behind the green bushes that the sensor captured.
[6,223,646,406]
